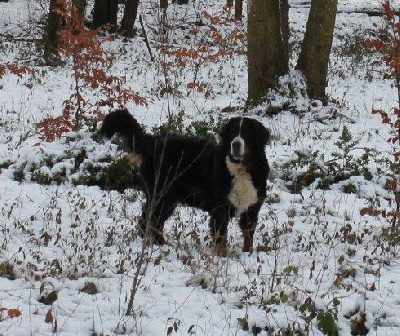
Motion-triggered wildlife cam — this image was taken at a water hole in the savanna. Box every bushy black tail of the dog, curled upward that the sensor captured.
[100,110,145,154]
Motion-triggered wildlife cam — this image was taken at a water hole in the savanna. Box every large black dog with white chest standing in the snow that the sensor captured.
[101,110,270,255]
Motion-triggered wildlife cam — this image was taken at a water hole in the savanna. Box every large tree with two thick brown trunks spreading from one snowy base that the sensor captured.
[248,0,338,103]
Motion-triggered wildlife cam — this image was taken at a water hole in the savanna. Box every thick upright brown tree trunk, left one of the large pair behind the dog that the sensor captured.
[247,0,289,103]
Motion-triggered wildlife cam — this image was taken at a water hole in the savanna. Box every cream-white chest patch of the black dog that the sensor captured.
[226,157,258,216]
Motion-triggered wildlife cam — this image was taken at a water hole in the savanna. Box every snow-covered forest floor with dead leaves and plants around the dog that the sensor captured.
[0,0,400,335]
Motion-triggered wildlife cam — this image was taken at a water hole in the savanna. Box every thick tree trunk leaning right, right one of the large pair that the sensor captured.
[296,0,338,103]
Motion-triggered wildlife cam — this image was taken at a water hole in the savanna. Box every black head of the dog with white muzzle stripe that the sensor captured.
[220,117,270,162]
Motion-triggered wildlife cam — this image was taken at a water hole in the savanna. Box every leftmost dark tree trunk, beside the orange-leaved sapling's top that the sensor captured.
[43,0,62,65]
